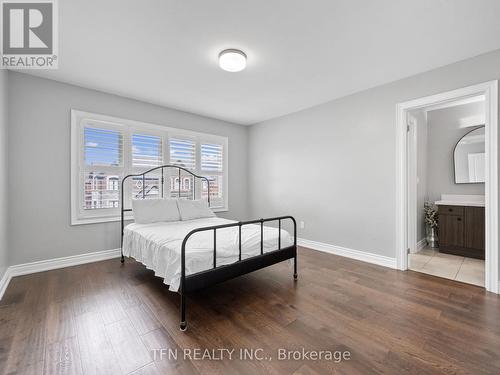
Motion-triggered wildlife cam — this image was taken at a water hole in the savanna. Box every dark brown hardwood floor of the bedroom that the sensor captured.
[0,249,500,374]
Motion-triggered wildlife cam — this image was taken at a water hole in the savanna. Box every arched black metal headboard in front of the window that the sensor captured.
[120,164,210,256]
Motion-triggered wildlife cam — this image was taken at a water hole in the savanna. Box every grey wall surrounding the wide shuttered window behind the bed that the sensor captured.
[8,72,248,264]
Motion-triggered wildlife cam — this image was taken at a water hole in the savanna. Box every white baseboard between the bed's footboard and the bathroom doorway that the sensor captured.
[297,238,397,268]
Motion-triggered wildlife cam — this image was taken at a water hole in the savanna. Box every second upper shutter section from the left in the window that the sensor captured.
[132,134,163,169]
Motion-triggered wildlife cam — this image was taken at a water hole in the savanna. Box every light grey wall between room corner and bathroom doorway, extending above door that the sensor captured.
[249,50,500,274]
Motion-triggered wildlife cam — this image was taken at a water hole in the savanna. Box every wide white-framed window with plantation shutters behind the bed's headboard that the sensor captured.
[71,110,228,224]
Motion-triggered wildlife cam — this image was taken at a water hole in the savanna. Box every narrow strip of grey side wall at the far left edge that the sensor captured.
[0,70,9,279]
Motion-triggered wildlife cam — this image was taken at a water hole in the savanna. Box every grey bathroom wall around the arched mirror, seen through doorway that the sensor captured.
[427,102,484,201]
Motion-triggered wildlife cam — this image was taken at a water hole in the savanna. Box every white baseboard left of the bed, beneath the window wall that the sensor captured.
[0,249,120,299]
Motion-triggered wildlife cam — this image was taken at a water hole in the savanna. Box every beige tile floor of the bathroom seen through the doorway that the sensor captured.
[408,247,484,287]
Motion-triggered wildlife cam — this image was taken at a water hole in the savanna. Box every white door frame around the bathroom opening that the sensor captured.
[396,80,499,293]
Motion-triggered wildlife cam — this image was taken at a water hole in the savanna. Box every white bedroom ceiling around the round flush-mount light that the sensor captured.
[24,0,500,124]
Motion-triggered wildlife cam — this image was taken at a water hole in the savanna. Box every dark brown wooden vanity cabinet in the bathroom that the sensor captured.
[438,206,485,259]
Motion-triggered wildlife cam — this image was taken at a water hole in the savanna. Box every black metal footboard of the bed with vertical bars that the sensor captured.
[179,216,297,331]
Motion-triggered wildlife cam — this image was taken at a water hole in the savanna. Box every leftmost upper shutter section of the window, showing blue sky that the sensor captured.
[84,126,123,167]
